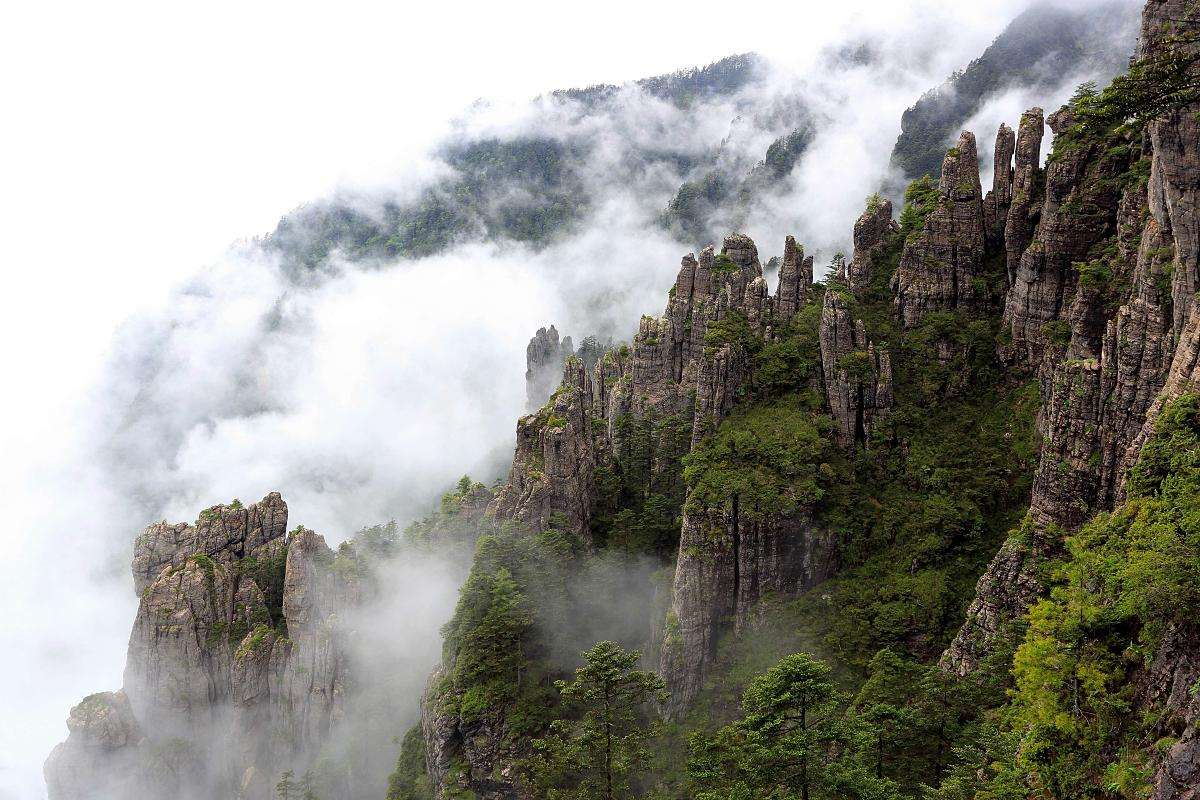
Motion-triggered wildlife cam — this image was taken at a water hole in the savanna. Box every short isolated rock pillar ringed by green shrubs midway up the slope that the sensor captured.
[820,283,892,446]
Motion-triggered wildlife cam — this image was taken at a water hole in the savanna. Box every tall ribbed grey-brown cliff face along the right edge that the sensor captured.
[942,1,1200,681]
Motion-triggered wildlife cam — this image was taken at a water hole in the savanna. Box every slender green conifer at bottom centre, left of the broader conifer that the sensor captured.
[528,642,666,800]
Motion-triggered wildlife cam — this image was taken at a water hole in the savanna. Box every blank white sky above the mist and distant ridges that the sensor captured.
[0,0,1099,800]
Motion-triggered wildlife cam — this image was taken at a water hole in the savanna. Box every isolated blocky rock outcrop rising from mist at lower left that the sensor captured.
[46,493,359,800]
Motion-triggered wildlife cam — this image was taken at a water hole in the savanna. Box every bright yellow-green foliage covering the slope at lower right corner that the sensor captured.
[979,395,1200,799]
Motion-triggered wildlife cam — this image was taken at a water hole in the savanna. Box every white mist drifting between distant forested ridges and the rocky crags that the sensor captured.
[0,2,1137,800]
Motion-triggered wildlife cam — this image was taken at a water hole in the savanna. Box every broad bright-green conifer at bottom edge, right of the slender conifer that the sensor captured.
[688,652,895,800]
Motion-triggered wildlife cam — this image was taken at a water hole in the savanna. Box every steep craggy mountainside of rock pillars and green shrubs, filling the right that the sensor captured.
[408,2,1200,799]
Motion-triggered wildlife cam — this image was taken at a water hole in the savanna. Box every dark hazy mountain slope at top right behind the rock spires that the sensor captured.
[892,2,1136,180]
